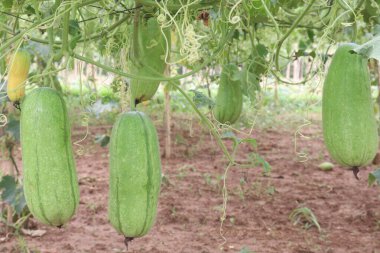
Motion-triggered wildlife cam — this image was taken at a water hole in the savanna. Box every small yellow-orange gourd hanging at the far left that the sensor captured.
[7,50,30,101]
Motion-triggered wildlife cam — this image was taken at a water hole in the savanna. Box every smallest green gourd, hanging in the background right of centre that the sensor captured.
[214,64,243,124]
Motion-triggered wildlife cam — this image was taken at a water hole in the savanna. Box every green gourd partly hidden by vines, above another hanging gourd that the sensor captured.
[130,18,171,103]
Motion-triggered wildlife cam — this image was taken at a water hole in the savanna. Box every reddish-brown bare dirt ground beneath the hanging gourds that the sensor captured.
[0,115,380,253]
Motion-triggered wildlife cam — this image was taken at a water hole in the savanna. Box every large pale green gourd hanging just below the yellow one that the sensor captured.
[20,88,79,226]
